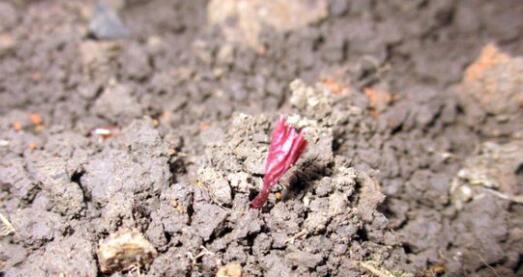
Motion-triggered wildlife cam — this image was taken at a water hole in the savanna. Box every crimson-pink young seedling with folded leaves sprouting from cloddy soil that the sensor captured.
[251,116,307,209]
